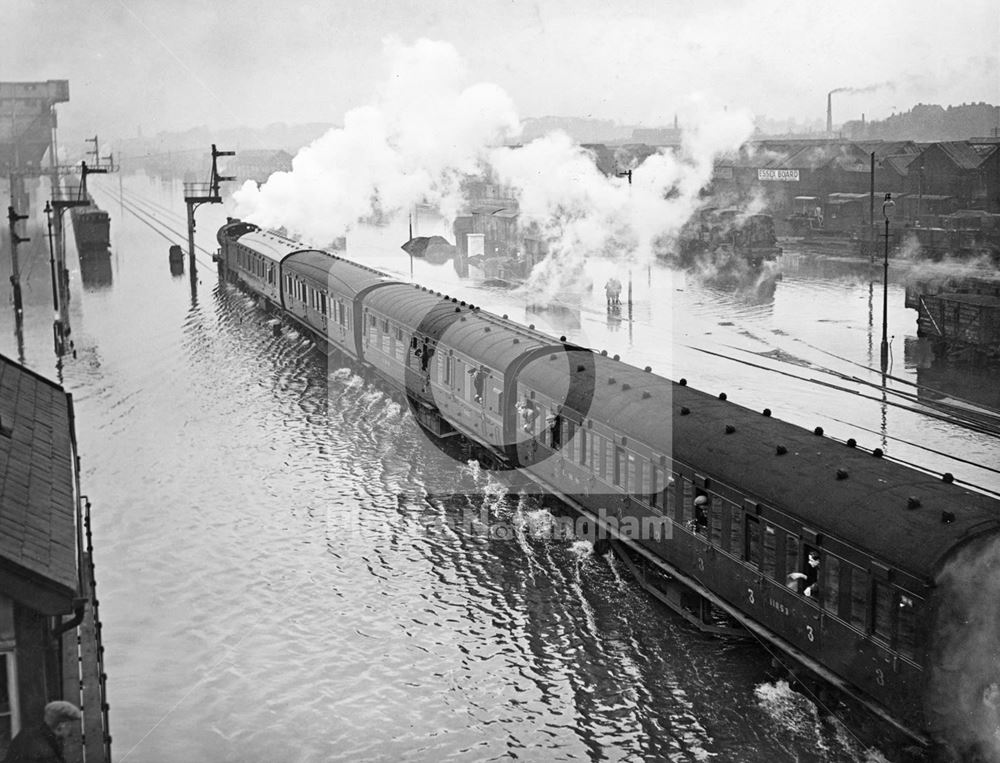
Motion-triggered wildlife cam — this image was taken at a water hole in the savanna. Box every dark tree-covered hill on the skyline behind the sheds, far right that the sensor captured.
[840,103,1000,142]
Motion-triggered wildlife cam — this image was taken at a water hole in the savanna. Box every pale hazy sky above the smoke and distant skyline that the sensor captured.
[7,0,1000,140]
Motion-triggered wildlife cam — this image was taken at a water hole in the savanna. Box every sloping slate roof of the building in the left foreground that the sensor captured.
[0,355,78,614]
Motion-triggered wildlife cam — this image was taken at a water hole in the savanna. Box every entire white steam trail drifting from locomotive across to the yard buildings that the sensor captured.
[234,38,753,297]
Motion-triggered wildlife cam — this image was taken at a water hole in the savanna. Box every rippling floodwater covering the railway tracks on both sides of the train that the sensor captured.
[0,176,1000,763]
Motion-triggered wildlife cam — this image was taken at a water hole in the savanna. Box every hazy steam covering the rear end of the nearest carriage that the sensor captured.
[925,538,1000,763]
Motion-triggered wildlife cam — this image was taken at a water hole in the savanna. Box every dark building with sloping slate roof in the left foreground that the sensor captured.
[0,355,111,763]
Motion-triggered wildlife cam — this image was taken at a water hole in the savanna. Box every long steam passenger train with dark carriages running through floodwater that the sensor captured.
[215,218,1000,761]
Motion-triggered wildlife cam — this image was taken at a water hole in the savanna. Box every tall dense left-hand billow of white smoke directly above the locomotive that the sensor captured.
[233,38,520,241]
